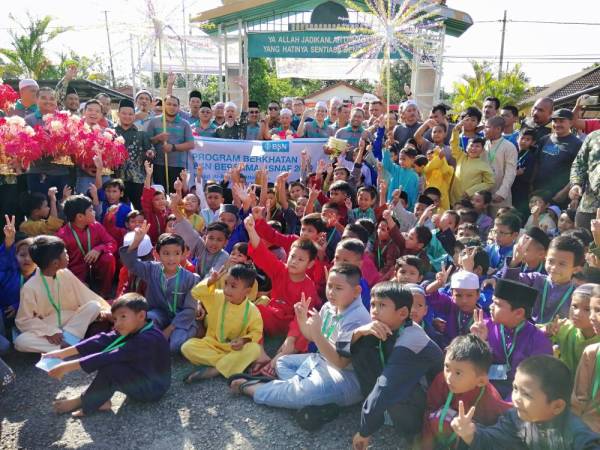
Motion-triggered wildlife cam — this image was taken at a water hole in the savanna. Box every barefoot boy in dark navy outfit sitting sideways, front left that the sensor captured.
[43,293,171,417]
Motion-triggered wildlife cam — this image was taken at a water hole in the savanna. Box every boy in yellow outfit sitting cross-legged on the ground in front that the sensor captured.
[181,264,263,383]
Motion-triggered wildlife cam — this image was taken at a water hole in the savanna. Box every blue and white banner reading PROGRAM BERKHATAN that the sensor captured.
[190,137,327,183]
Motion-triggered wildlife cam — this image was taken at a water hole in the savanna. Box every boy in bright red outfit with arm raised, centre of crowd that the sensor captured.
[244,216,320,374]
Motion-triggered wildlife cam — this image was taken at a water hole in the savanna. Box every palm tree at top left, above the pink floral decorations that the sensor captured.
[0,14,69,79]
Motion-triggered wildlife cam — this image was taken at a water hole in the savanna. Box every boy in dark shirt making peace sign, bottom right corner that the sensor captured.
[451,355,600,450]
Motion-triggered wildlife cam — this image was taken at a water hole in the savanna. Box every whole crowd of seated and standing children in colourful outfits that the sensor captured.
[0,99,600,450]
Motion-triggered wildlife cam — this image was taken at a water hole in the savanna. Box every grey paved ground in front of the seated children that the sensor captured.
[0,353,402,450]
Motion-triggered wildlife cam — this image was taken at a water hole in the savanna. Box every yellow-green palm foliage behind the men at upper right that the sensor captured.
[451,61,529,112]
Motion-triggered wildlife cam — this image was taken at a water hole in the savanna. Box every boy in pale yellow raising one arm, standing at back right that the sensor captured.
[450,119,496,204]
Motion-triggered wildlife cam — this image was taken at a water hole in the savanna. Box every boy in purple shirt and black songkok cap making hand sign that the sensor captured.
[471,279,552,399]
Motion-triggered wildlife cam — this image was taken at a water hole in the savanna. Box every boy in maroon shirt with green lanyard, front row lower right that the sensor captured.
[421,334,511,450]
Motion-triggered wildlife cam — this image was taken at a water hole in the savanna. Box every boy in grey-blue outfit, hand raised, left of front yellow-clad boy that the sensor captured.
[120,221,200,353]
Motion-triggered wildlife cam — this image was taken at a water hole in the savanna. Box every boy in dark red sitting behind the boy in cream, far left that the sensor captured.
[56,195,117,298]
